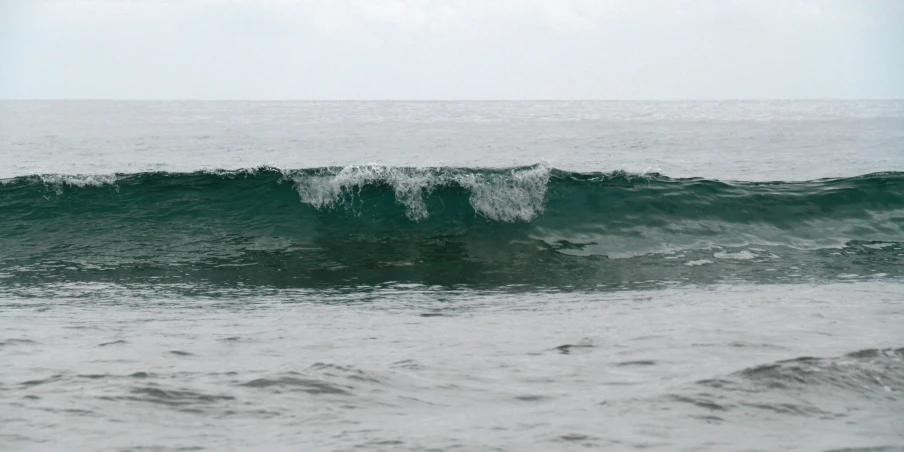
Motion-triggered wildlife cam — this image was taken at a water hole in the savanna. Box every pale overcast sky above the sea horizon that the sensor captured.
[0,0,904,99]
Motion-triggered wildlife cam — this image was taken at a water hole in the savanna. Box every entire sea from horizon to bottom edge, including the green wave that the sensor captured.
[0,101,904,451]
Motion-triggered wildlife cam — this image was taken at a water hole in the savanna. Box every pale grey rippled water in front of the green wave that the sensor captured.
[0,282,904,451]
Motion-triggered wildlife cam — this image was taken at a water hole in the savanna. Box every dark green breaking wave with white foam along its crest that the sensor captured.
[0,165,904,287]
